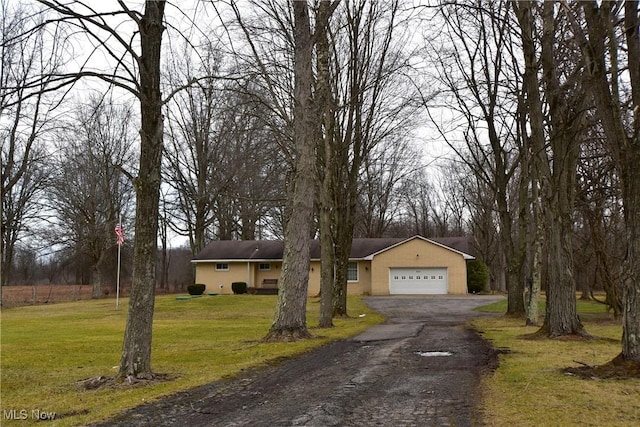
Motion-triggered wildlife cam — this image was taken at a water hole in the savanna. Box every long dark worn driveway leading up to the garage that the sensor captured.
[96,296,502,427]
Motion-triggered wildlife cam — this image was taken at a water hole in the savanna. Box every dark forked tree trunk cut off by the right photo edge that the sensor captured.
[578,1,640,366]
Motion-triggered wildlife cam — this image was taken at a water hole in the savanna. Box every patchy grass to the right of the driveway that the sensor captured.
[473,301,640,427]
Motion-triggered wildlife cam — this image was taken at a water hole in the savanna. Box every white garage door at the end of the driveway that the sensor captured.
[389,267,449,295]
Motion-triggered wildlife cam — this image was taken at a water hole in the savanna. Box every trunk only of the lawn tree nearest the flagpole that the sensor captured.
[118,0,166,379]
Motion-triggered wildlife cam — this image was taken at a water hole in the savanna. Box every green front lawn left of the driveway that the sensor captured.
[0,295,383,426]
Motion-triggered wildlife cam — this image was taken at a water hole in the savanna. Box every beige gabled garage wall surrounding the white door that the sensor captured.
[371,239,467,295]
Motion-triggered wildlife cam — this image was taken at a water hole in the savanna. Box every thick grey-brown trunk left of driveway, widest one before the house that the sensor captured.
[264,1,317,341]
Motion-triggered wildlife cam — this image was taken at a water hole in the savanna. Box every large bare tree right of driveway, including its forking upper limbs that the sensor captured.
[513,2,586,336]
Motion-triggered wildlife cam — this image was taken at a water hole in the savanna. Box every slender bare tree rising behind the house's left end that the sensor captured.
[165,49,234,254]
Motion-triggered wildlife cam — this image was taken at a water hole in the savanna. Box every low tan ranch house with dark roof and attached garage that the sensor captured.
[192,236,474,296]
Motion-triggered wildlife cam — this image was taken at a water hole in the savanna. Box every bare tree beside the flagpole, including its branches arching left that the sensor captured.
[31,0,166,380]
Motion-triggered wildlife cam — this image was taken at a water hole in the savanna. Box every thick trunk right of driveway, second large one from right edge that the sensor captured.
[540,3,586,337]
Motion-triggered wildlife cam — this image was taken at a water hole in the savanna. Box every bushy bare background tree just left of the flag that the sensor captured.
[49,96,135,298]
